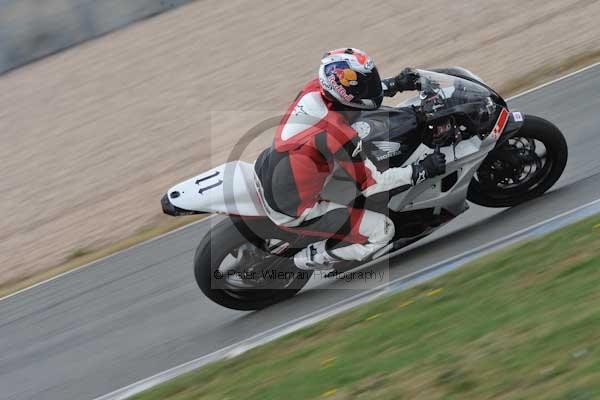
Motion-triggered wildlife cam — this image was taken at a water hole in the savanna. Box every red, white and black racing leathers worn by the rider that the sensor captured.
[255,80,412,267]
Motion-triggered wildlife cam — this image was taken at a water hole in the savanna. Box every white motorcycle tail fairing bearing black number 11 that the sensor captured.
[168,161,266,216]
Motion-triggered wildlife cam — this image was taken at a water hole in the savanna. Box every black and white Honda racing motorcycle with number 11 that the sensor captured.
[161,68,568,310]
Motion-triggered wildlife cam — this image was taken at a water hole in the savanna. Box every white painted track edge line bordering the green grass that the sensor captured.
[95,199,600,400]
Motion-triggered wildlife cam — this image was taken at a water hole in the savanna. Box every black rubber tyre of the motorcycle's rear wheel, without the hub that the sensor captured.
[194,219,312,311]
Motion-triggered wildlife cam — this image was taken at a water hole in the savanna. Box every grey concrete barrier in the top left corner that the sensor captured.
[0,0,193,74]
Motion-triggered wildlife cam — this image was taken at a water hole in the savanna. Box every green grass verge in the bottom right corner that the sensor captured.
[133,216,600,400]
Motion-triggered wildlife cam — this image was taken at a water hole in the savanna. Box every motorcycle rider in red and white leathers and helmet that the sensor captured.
[254,48,446,269]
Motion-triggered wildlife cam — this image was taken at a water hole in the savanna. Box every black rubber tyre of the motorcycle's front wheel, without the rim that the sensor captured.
[467,115,568,207]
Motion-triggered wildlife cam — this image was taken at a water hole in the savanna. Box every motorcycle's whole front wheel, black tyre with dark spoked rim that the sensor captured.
[467,115,568,207]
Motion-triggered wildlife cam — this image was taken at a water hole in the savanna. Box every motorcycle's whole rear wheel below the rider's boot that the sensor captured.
[194,219,312,311]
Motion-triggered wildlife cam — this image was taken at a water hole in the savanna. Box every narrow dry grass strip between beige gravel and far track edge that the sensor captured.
[0,50,600,297]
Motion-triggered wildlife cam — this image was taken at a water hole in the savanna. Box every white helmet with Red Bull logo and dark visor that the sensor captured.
[319,48,383,110]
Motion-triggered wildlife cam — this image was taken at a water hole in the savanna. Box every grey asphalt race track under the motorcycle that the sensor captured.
[0,65,600,400]
